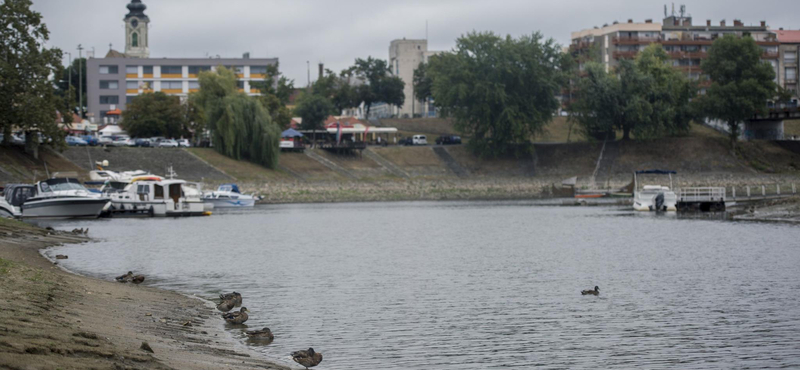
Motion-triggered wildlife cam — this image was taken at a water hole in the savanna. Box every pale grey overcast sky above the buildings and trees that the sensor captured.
[33,0,800,86]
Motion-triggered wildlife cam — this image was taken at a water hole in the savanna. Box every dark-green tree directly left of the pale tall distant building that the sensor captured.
[352,57,405,117]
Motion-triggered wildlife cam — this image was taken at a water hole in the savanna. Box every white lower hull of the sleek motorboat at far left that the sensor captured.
[22,197,109,218]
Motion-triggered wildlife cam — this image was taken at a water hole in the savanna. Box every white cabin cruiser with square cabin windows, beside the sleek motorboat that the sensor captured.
[108,176,211,217]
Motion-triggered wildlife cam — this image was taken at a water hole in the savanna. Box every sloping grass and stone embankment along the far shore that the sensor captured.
[0,136,800,203]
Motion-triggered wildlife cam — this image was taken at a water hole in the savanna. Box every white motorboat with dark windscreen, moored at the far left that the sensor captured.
[0,178,109,218]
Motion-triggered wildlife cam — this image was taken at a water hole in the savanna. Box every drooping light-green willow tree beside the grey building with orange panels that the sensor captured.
[192,67,280,168]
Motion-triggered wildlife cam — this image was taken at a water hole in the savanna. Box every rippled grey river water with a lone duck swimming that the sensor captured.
[42,202,800,370]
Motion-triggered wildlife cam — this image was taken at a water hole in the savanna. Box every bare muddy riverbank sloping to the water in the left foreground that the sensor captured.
[0,219,288,370]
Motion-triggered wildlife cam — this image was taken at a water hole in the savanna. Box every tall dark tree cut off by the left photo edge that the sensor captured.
[0,0,64,156]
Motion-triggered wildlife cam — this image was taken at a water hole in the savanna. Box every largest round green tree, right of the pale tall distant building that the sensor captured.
[427,32,562,156]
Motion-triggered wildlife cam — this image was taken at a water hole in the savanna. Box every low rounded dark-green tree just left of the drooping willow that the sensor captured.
[122,91,189,138]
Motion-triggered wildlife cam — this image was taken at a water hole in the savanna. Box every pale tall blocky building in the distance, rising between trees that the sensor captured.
[389,38,441,118]
